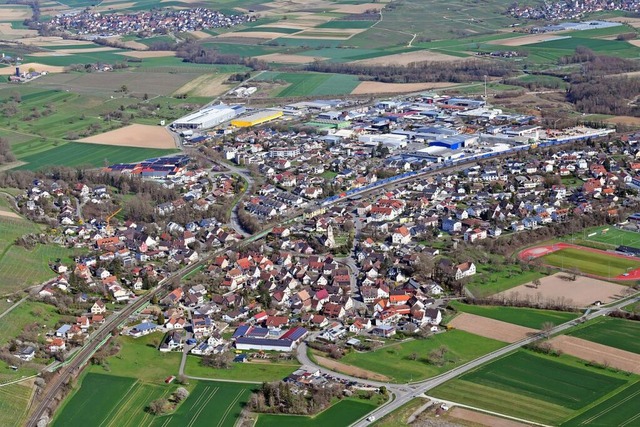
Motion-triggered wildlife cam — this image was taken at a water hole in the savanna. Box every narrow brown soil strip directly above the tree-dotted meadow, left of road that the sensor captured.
[449,313,537,343]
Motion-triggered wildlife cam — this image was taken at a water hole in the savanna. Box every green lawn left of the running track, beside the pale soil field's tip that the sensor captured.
[467,264,544,298]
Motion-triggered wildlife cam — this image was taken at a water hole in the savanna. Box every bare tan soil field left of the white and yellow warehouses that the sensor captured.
[79,124,176,148]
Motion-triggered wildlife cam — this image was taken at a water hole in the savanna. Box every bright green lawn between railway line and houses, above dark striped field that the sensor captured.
[89,332,182,384]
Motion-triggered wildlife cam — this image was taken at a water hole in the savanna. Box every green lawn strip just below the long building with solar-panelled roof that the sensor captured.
[185,356,300,382]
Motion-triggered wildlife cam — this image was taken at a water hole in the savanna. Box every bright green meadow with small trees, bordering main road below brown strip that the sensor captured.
[340,330,505,383]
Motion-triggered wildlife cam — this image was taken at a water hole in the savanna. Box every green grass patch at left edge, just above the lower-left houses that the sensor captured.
[0,301,60,345]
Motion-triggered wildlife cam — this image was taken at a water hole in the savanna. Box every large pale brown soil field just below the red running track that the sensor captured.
[495,273,627,307]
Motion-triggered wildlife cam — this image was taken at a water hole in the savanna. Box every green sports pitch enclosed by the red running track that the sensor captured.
[541,248,640,277]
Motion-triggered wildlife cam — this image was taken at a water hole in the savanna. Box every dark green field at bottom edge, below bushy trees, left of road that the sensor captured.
[256,399,376,427]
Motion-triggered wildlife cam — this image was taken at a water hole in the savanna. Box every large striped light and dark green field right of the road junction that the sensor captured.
[431,350,635,425]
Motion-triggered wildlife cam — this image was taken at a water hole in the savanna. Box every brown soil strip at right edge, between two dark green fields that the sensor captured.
[550,335,640,374]
